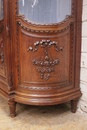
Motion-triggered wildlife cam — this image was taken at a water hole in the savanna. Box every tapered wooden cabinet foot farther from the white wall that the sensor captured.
[8,99,16,118]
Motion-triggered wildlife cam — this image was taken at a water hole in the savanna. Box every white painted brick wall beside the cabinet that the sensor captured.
[78,0,87,113]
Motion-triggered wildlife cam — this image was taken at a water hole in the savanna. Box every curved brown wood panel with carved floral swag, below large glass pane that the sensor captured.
[17,21,73,88]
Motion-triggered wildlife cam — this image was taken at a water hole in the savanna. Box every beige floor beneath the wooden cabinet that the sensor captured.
[0,97,87,130]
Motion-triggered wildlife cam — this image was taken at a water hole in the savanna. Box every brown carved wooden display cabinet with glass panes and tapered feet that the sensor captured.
[0,0,82,117]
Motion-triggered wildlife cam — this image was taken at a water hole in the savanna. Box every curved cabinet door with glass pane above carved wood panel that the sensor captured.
[15,0,76,97]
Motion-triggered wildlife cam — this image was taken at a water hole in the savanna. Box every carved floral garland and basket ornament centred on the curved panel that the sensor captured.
[28,40,63,80]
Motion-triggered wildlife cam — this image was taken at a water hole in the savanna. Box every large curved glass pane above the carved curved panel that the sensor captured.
[19,0,71,24]
